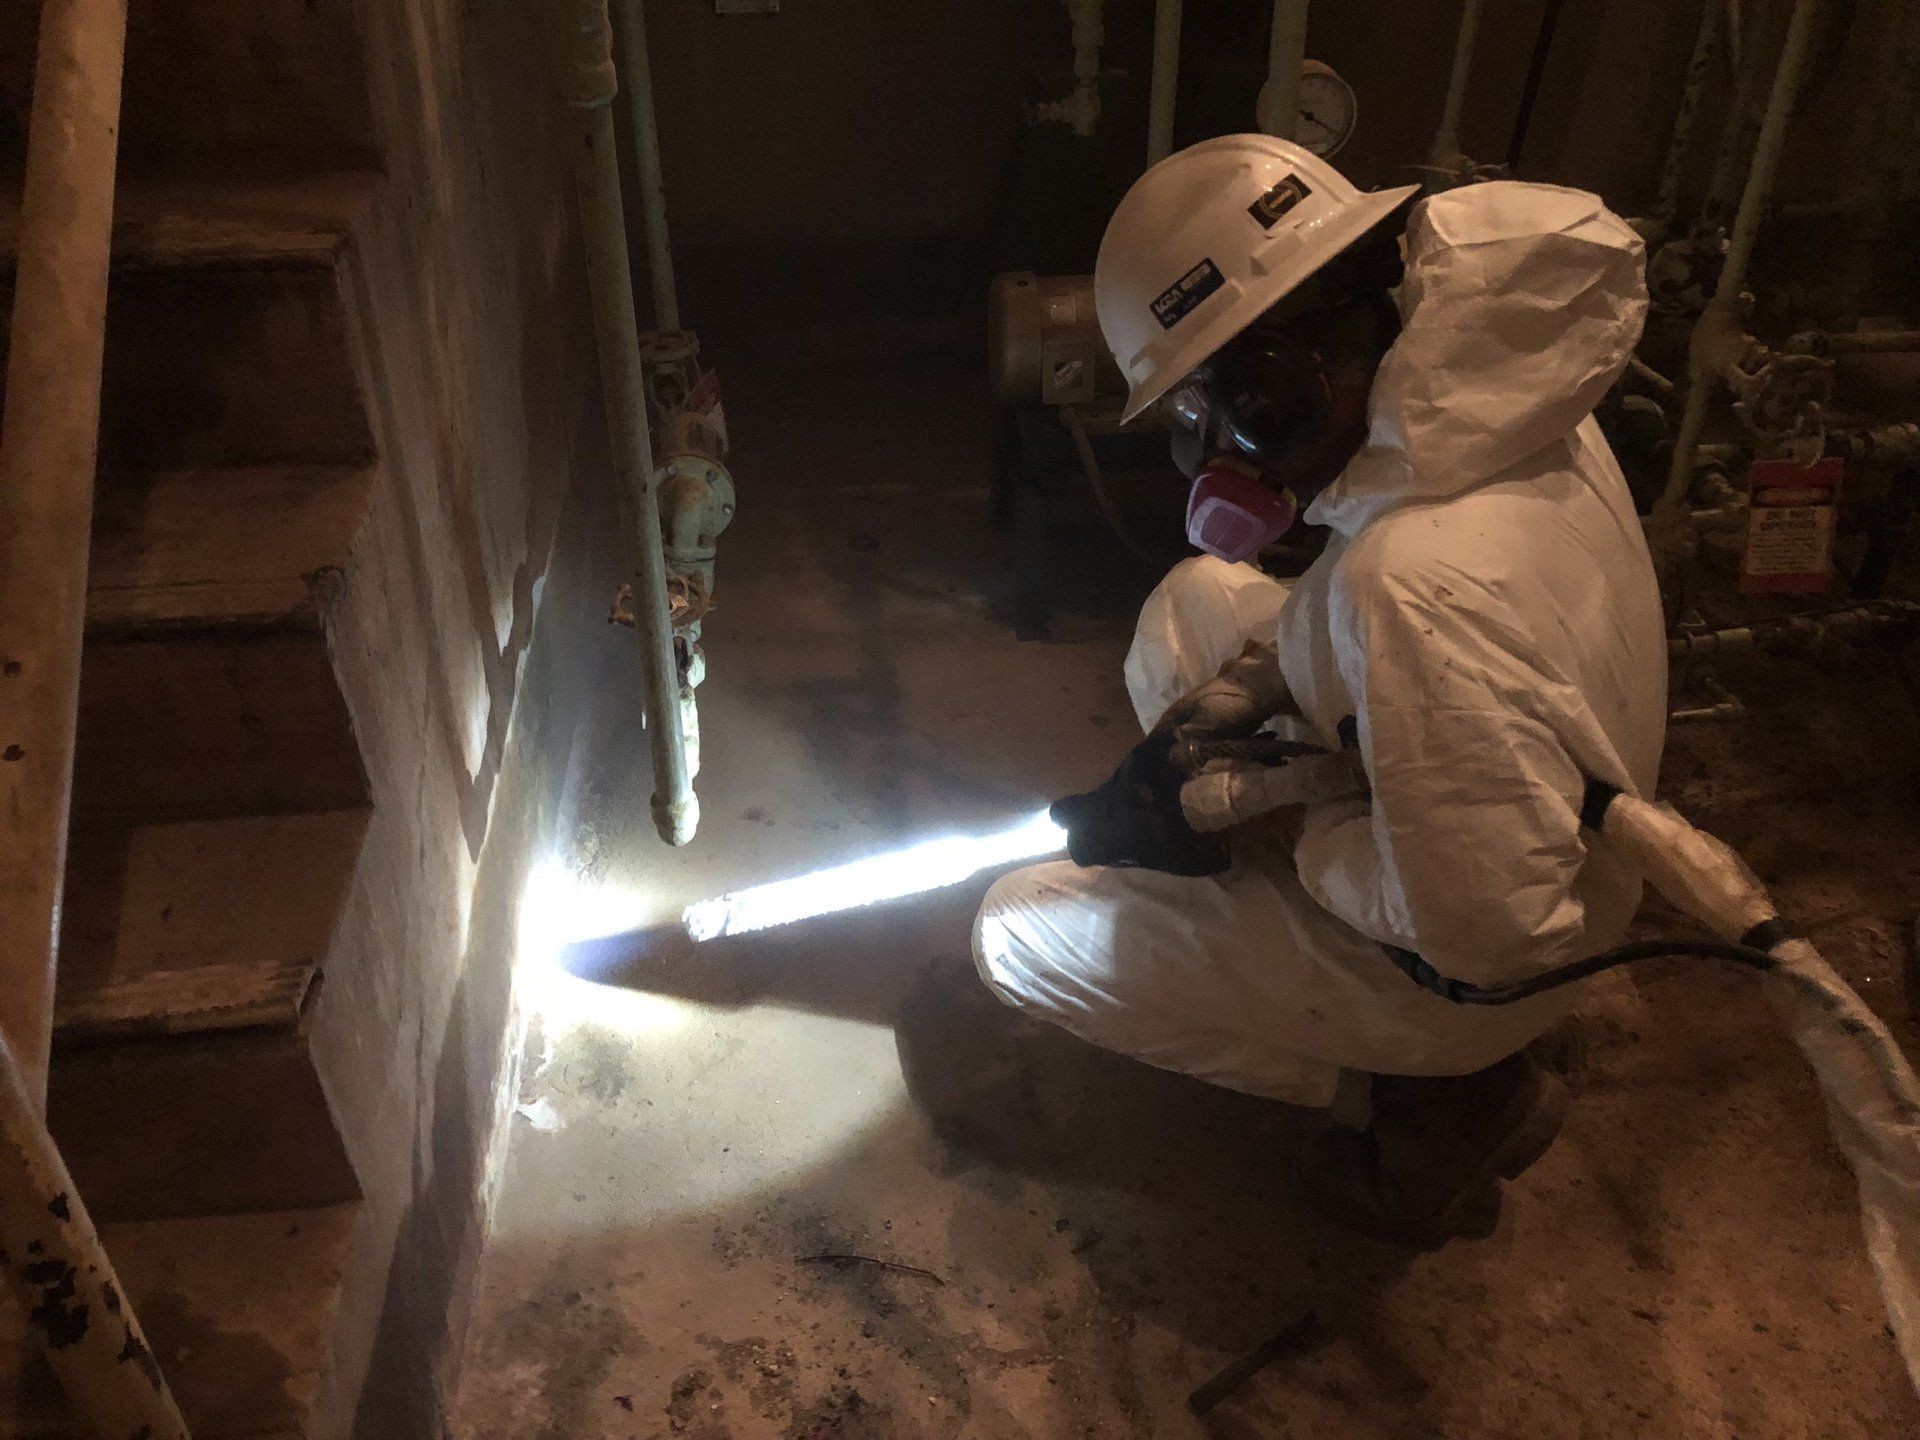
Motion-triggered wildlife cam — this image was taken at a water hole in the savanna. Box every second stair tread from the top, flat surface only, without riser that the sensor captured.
[86,465,374,628]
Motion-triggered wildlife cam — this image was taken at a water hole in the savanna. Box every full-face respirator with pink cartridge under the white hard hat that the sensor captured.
[1167,301,1384,563]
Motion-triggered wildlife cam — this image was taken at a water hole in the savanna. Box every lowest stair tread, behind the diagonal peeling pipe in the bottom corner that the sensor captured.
[0,1204,359,1440]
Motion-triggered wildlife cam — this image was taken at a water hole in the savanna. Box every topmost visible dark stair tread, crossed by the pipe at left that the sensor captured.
[0,169,380,267]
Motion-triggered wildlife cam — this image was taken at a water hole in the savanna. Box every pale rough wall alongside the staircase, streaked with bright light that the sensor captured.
[299,0,611,1440]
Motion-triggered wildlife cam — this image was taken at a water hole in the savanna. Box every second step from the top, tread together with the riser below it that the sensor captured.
[75,467,376,816]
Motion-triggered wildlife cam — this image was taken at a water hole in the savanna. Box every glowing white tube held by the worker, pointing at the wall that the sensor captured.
[684,810,1068,941]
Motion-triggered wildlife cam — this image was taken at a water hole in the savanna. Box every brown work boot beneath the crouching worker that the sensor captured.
[1294,1054,1567,1246]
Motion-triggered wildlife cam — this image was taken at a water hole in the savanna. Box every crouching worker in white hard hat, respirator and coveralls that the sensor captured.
[973,136,1667,1242]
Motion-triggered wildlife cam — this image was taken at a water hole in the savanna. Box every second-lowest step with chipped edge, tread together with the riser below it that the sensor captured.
[48,808,367,1219]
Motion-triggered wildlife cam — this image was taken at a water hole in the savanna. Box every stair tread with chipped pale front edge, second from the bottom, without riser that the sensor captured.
[54,810,367,1044]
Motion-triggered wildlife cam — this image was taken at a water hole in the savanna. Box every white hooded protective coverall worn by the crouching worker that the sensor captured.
[973,182,1667,1106]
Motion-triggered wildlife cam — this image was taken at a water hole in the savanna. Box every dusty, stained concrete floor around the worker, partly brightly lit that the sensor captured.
[457,361,1920,1440]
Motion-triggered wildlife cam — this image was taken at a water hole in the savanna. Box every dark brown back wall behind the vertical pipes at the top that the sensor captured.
[649,0,1901,252]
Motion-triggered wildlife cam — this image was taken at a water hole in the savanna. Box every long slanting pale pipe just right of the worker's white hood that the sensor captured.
[1661,0,1820,520]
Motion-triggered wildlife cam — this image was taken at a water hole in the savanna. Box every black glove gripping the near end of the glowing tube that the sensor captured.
[1048,730,1229,876]
